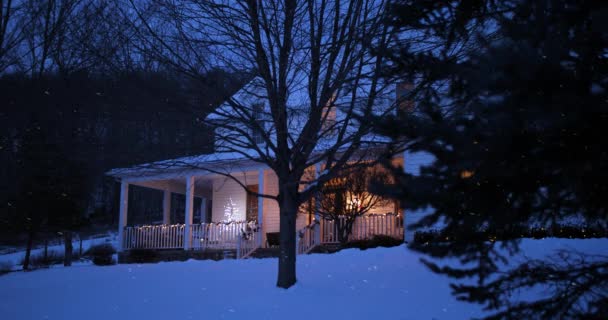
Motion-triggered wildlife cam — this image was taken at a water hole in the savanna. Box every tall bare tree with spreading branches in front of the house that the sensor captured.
[123,0,400,288]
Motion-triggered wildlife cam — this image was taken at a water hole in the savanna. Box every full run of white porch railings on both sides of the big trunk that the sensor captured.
[122,214,403,259]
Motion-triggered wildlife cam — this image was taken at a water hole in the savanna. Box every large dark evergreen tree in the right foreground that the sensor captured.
[379,0,608,319]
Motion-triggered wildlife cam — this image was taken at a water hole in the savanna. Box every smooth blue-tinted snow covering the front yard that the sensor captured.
[0,239,608,320]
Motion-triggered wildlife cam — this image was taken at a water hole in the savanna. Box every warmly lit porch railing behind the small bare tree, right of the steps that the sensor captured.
[321,214,403,243]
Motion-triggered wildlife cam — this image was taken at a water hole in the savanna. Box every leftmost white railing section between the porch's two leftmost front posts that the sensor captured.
[123,224,185,250]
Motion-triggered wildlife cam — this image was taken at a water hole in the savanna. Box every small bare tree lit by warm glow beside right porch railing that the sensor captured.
[314,166,392,244]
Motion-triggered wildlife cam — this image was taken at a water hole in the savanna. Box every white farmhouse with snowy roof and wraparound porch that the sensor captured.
[108,79,428,258]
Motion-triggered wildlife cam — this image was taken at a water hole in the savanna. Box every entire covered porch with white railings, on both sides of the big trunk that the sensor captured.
[113,159,404,258]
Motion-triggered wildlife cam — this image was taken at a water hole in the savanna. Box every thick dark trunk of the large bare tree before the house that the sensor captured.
[277,187,298,289]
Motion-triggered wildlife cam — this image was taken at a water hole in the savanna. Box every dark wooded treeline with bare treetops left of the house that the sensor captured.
[0,0,249,252]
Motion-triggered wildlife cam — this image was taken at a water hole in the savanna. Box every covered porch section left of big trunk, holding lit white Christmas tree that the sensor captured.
[118,169,264,255]
